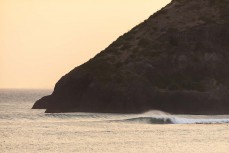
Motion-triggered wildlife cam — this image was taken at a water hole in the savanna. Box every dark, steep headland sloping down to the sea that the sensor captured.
[33,0,229,114]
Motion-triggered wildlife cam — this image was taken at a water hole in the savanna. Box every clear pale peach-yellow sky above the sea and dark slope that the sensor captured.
[0,0,171,89]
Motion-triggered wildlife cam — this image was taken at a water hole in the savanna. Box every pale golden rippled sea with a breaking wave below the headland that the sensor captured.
[0,89,229,153]
